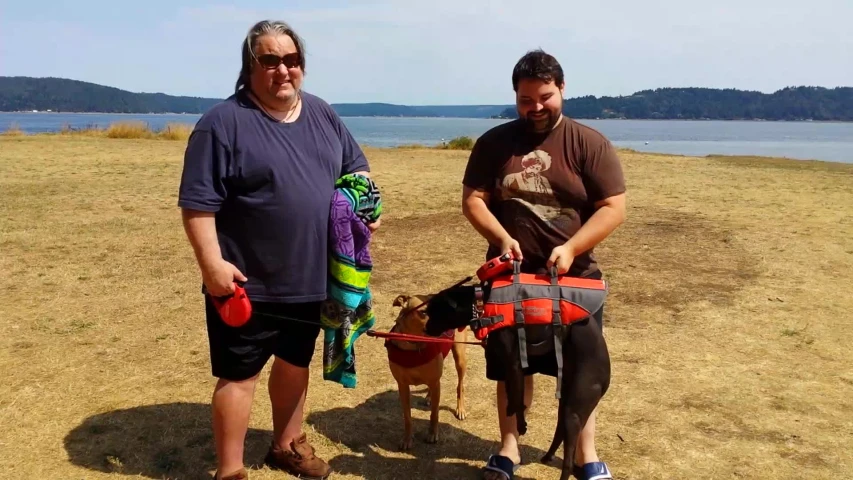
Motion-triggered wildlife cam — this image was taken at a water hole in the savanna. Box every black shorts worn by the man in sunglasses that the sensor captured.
[205,295,321,381]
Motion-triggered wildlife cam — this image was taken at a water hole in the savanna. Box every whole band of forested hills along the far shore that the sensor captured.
[0,77,853,121]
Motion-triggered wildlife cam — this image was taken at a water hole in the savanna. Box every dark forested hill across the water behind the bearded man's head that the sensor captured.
[501,87,853,121]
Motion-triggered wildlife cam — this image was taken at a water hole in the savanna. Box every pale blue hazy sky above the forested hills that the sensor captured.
[0,0,853,105]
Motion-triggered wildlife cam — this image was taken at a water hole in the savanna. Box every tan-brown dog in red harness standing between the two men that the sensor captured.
[385,295,468,450]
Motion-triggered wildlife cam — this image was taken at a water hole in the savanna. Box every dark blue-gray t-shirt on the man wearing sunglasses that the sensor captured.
[178,91,369,302]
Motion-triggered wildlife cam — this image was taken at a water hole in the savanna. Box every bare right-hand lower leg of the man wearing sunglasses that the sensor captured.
[269,357,308,450]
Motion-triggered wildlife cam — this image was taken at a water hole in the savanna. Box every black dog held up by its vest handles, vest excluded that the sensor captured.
[425,283,610,480]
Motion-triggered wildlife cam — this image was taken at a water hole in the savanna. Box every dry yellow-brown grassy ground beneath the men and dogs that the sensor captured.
[0,135,853,480]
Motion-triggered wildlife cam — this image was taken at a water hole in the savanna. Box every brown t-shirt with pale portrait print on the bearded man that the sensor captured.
[462,116,625,276]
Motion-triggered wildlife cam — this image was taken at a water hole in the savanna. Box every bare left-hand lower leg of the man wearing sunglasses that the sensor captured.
[211,375,258,476]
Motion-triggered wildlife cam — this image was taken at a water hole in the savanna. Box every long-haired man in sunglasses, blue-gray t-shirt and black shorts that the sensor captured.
[178,21,379,480]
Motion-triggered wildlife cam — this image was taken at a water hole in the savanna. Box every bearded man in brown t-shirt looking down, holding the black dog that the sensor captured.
[462,50,625,480]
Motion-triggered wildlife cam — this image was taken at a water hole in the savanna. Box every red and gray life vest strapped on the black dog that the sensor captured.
[471,260,607,398]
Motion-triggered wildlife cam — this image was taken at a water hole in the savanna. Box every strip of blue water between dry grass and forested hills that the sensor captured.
[0,113,853,163]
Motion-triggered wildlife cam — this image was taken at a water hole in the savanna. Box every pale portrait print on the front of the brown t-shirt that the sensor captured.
[500,150,561,223]
